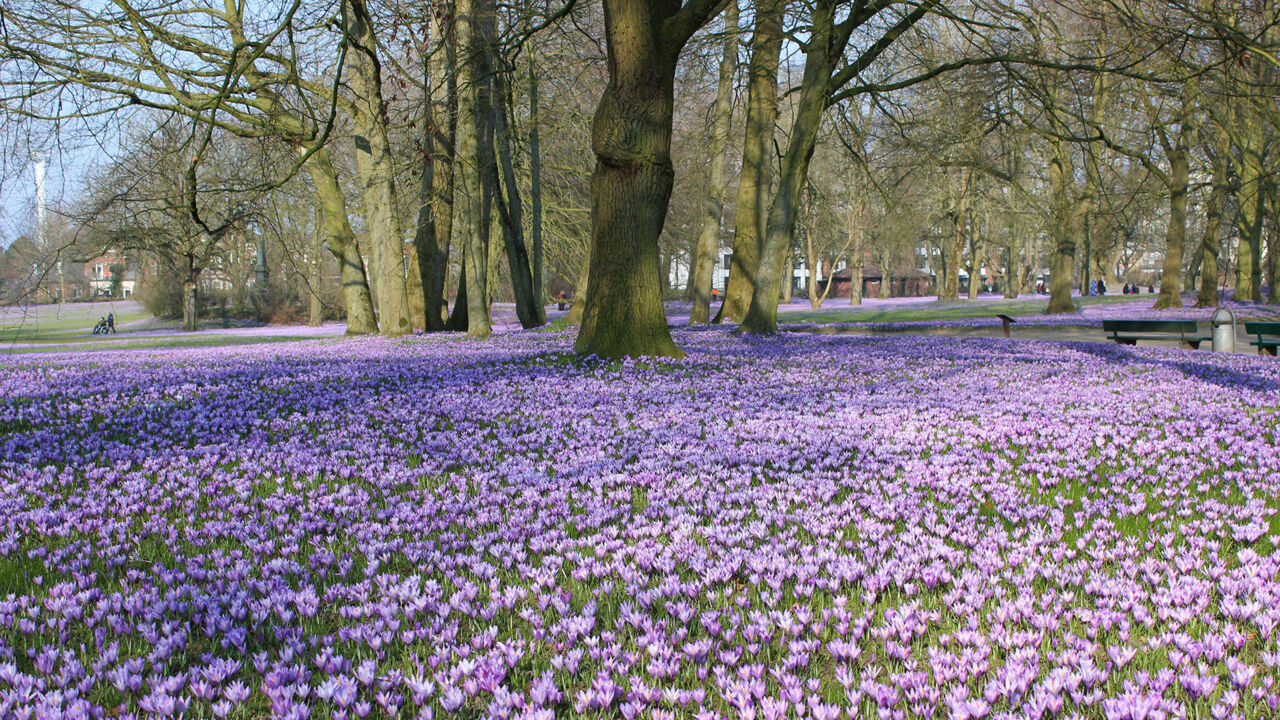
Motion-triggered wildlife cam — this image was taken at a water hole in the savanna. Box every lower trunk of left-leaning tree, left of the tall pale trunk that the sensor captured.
[306,147,378,334]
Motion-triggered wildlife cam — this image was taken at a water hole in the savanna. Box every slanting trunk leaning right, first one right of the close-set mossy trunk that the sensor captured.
[741,0,842,334]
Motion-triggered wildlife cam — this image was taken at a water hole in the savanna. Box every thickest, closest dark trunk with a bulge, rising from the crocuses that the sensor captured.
[575,0,719,357]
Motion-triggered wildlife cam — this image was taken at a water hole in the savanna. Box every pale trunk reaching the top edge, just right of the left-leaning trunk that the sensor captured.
[343,0,412,336]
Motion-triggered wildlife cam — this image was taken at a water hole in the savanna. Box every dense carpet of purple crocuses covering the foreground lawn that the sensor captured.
[0,331,1280,720]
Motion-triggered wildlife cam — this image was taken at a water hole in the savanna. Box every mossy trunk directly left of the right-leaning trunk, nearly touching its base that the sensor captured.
[721,0,786,322]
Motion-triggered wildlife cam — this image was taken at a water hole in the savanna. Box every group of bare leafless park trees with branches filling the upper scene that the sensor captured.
[0,0,1280,356]
